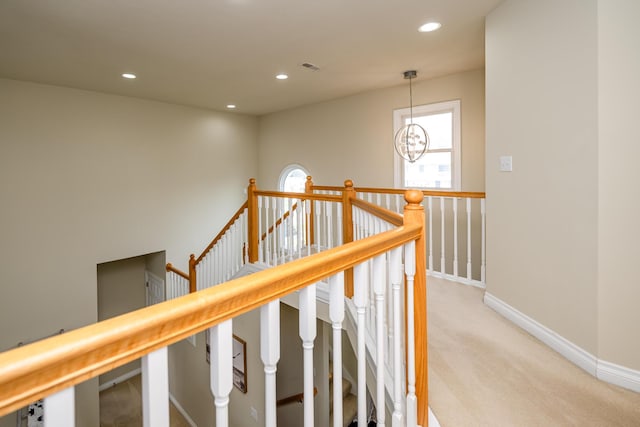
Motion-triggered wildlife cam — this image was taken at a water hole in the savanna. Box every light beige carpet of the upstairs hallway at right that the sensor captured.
[427,277,640,427]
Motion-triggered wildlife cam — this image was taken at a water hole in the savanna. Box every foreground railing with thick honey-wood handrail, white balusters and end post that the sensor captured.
[0,191,428,427]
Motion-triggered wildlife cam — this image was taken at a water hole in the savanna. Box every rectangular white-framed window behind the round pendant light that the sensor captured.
[393,100,460,190]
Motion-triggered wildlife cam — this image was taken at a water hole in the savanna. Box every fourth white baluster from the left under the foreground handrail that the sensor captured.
[260,300,280,427]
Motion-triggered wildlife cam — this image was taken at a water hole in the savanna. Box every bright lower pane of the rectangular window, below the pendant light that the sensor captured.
[404,152,451,188]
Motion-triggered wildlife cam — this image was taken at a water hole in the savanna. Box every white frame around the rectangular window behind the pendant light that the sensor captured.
[393,99,462,191]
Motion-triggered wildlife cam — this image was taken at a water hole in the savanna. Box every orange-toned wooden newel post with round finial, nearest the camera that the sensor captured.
[404,190,429,427]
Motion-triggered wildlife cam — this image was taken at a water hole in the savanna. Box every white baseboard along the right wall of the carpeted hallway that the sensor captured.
[484,292,640,392]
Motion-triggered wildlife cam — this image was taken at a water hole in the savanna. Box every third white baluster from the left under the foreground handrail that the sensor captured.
[209,320,233,427]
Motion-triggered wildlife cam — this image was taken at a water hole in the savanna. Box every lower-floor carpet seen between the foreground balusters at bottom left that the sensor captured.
[100,375,190,427]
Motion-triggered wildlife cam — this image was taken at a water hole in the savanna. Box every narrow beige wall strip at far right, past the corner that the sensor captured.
[597,0,640,370]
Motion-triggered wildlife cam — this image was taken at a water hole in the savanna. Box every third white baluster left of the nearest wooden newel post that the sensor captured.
[373,255,386,427]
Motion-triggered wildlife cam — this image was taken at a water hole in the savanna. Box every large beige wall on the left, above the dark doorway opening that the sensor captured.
[0,80,257,427]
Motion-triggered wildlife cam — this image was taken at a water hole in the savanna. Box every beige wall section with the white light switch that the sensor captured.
[486,0,598,354]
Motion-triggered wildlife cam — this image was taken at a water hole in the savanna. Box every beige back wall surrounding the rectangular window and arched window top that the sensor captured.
[258,70,484,191]
